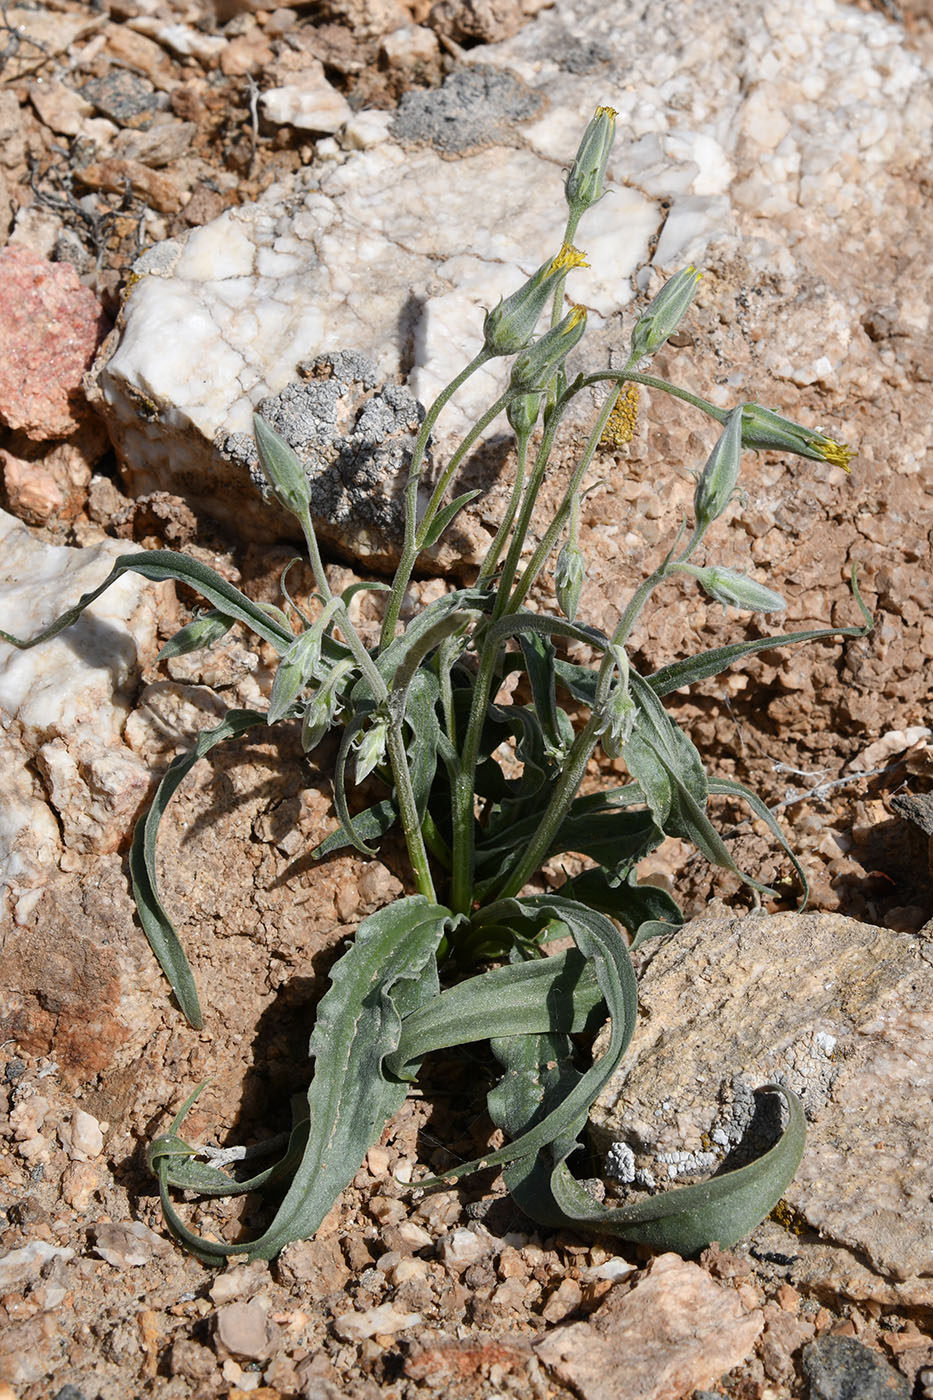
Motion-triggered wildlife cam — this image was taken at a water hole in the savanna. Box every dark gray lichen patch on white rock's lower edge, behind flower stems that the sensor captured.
[217,350,430,563]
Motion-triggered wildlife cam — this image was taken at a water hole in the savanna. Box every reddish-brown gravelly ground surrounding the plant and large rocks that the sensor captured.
[0,0,933,1400]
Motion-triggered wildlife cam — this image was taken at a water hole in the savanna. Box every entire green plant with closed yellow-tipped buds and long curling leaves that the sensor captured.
[1,108,870,1259]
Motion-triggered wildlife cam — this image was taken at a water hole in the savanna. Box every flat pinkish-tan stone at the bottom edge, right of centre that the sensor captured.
[535,1254,765,1400]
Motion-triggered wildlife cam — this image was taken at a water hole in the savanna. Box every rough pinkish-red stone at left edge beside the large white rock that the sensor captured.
[0,244,109,442]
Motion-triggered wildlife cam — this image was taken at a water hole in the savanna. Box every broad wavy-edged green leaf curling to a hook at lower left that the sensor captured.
[156,895,457,1259]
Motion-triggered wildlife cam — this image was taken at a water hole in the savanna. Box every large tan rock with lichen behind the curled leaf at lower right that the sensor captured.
[593,914,933,1282]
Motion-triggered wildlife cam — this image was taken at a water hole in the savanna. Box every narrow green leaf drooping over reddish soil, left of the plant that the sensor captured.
[129,710,266,1030]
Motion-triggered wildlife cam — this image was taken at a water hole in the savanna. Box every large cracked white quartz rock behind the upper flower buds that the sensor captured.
[92,140,658,538]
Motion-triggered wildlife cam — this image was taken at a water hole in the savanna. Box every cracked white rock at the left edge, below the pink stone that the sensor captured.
[0,512,163,923]
